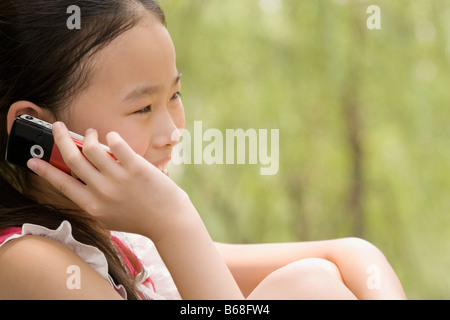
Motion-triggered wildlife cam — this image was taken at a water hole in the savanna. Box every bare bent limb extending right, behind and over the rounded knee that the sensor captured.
[218,238,406,300]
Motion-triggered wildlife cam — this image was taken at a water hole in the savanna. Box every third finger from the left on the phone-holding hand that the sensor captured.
[83,129,118,173]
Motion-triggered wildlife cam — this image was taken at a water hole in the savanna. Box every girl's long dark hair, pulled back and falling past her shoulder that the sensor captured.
[0,0,165,299]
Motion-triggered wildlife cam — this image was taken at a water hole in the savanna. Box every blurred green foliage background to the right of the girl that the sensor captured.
[160,0,450,299]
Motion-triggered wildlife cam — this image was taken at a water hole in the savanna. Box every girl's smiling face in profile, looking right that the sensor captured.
[60,14,185,170]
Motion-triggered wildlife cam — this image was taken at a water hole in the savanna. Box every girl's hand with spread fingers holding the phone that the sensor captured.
[27,122,191,240]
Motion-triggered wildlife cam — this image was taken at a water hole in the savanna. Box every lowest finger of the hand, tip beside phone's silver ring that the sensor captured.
[27,158,89,207]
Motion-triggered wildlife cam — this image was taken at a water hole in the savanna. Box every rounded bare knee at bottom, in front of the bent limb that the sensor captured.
[247,259,356,300]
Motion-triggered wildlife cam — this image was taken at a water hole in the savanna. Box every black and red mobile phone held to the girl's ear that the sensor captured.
[5,114,114,175]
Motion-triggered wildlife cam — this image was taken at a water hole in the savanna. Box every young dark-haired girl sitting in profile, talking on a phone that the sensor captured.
[0,0,405,299]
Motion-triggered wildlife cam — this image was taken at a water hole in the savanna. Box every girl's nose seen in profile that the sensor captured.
[153,110,182,148]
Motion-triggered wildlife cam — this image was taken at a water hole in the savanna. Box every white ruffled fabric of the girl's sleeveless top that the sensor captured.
[0,221,181,300]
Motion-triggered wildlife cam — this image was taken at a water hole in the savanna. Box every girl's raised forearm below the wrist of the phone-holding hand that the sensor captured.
[150,206,243,300]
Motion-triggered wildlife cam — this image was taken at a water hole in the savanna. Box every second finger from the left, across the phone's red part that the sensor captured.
[53,122,99,183]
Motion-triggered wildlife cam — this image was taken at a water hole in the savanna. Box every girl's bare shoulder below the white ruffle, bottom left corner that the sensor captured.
[0,235,118,299]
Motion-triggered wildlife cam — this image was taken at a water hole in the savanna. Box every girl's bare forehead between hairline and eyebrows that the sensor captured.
[84,15,178,95]
